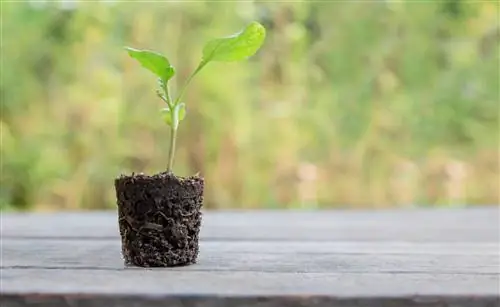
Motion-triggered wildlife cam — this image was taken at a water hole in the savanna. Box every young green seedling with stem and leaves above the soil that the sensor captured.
[125,21,266,173]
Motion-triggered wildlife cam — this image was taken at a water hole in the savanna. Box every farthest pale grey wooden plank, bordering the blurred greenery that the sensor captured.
[1,206,500,242]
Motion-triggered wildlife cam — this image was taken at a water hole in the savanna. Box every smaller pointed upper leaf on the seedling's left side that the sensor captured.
[125,47,175,83]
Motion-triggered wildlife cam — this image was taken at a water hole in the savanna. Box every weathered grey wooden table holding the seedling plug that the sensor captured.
[0,207,500,307]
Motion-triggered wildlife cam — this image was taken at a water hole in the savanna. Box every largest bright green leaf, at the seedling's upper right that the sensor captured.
[202,21,266,64]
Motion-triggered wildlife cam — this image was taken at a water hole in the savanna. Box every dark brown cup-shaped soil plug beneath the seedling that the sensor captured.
[115,173,204,267]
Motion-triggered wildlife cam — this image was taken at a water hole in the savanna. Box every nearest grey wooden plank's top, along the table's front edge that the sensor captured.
[2,268,498,298]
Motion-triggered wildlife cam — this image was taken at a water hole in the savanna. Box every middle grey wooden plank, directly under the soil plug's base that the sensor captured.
[2,240,500,276]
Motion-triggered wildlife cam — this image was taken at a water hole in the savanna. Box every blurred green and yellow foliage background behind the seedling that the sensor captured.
[0,0,500,210]
